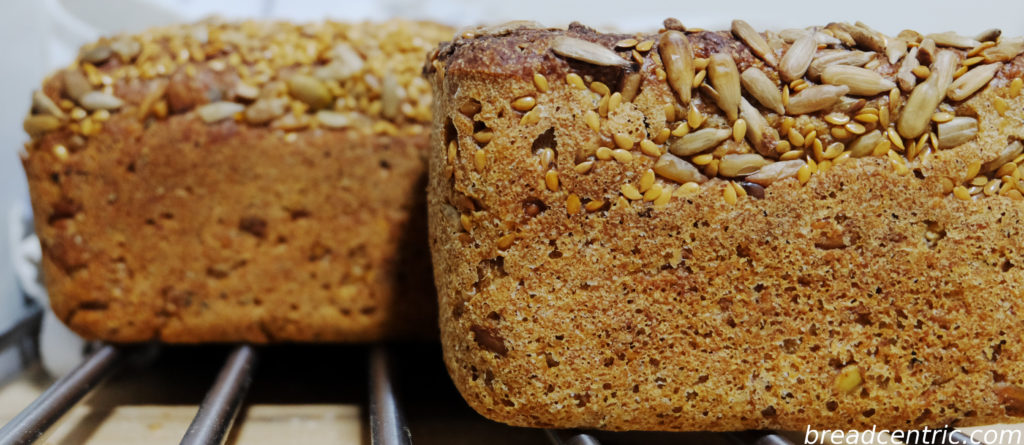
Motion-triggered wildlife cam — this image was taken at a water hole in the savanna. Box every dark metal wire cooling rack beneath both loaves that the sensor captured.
[0,307,981,445]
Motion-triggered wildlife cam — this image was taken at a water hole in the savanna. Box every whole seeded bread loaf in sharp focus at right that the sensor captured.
[425,19,1024,431]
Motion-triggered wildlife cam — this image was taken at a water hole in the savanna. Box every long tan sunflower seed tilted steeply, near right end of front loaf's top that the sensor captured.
[896,50,958,139]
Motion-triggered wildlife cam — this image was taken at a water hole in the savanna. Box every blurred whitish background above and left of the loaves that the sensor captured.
[0,0,1024,368]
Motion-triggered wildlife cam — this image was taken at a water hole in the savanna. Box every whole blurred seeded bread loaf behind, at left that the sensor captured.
[23,21,452,343]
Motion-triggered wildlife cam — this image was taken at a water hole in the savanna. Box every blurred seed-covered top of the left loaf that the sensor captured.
[25,20,451,152]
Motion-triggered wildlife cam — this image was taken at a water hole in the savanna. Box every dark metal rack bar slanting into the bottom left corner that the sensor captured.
[0,345,123,445]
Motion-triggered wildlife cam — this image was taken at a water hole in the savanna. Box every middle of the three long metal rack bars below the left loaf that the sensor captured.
[181,345,256,445]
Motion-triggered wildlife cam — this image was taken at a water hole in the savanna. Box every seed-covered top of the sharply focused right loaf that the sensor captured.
[425,18,1024,199]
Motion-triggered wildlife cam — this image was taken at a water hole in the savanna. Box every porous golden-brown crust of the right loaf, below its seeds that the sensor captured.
[427,21,1024,431]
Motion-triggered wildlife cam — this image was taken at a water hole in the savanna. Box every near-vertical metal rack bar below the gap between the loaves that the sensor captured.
[370,346,413,445]
